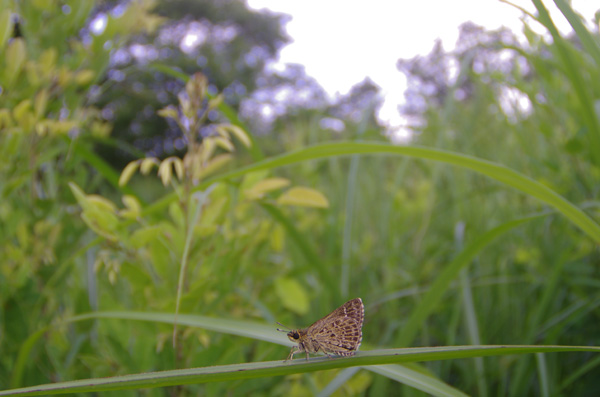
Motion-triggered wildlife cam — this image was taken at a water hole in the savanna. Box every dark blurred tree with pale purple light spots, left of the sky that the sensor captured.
[94,0,289,165]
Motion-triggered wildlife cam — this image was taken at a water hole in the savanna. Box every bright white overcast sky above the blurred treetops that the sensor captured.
[247,0,600,135]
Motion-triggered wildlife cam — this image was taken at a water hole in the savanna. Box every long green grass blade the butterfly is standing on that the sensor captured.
[0,346,600,396]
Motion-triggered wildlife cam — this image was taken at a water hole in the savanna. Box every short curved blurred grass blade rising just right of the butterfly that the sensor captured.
[399,214,545,346]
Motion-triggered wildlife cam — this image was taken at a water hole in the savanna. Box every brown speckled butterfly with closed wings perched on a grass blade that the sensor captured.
[277,298,365,361]
